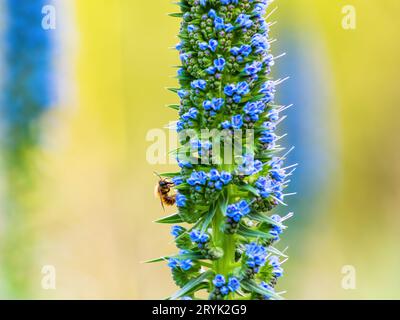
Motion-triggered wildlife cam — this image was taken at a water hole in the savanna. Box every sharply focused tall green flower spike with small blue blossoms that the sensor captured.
[152,0,291,300]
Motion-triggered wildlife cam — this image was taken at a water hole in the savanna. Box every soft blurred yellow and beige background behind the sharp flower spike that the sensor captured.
[0,0,400,299]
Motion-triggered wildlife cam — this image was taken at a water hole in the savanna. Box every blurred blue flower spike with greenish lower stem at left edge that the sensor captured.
[0,0,54,299]
